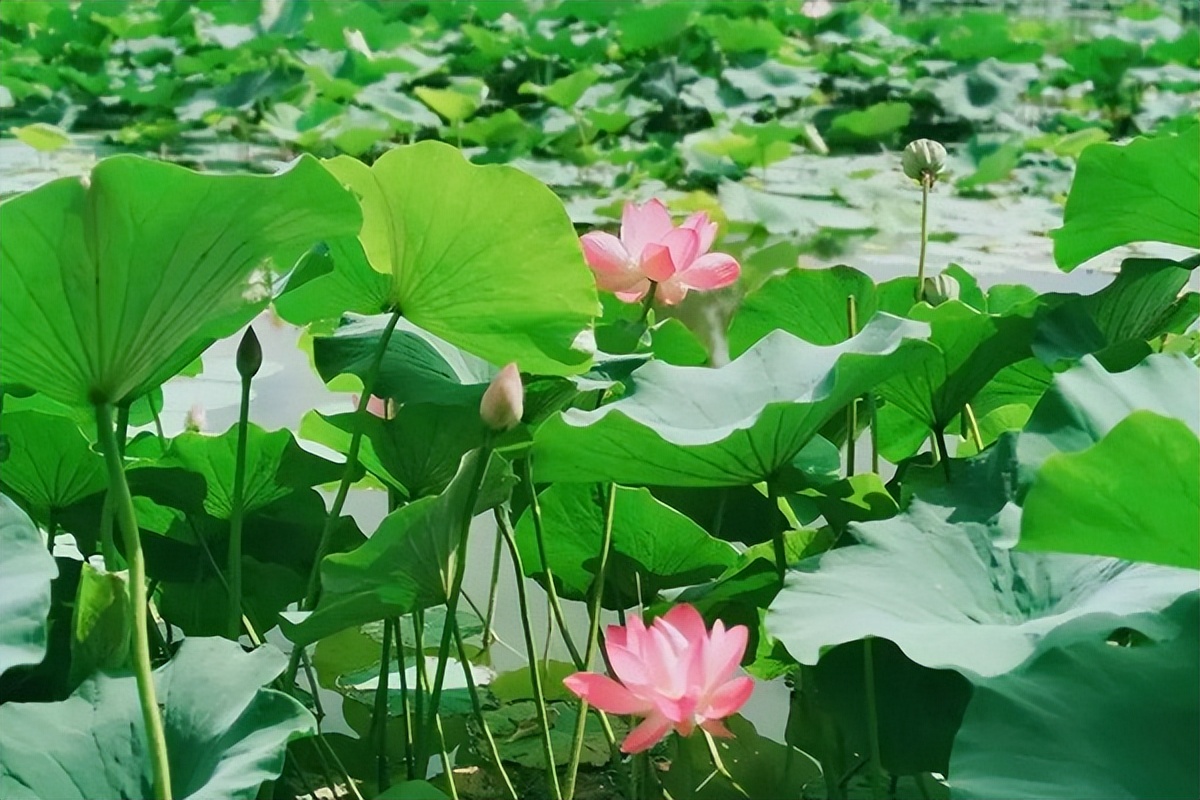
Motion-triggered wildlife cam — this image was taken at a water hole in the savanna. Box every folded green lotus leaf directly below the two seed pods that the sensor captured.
[878,300,1036,431]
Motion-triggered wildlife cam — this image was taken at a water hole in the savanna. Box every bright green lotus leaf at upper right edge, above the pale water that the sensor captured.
[1050,126,1200,271]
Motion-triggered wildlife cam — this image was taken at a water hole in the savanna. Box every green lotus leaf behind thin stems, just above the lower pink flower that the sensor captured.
[515,483,737,608]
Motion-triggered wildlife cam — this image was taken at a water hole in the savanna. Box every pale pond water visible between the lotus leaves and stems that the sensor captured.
[0,136,1200,753]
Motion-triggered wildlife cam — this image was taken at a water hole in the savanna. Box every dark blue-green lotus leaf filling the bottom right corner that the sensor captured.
[949,593,1200,800]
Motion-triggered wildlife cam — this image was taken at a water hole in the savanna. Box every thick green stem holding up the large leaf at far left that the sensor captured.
[96,403,172,800]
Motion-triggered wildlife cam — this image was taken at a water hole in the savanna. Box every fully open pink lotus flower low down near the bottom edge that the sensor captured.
[563,603,754,753]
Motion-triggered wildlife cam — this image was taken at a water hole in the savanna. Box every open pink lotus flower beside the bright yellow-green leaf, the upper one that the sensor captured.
[580,200,742,306]
